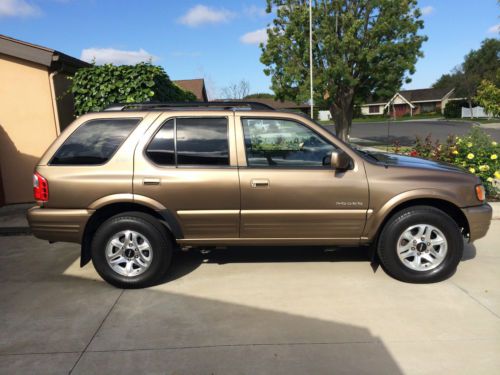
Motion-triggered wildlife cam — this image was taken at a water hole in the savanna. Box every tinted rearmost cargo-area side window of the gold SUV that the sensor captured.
[50,118,140,165]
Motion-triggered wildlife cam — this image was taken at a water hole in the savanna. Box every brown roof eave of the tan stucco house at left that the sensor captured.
[0,34,90,73]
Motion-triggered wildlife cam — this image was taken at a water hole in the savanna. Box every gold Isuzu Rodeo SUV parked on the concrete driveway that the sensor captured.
[28,102,492,288]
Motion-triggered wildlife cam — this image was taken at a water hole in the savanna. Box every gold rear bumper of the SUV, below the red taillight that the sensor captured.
[27,206,94,243]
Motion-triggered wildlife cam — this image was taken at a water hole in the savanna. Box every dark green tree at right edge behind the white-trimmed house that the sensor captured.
[433,39,500,113]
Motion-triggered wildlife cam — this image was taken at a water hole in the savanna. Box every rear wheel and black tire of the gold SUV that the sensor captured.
[91,212,174,289]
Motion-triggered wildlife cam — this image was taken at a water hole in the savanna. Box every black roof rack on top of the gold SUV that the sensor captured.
[104,100,275,111]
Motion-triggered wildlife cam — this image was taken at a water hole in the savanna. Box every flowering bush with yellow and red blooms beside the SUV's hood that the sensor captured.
[395,127,500,197]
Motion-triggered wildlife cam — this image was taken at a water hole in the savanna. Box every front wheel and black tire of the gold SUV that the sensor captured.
[377,206,464,283]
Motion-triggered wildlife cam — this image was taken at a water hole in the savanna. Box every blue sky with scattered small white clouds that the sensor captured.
[0,0,500,99]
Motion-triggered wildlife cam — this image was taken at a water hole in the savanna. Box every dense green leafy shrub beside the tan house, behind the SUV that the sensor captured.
[70,63,196,115]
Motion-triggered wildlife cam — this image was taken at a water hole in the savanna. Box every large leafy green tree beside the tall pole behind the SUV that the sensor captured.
[261,0,427,140]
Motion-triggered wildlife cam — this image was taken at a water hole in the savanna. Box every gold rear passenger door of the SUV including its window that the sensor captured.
[134,111,240,239]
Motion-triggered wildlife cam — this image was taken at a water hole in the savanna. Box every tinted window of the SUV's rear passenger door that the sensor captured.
[146,117,229,166]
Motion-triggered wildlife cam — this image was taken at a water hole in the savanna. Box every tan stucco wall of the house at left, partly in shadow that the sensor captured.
[0,54,56,204]
